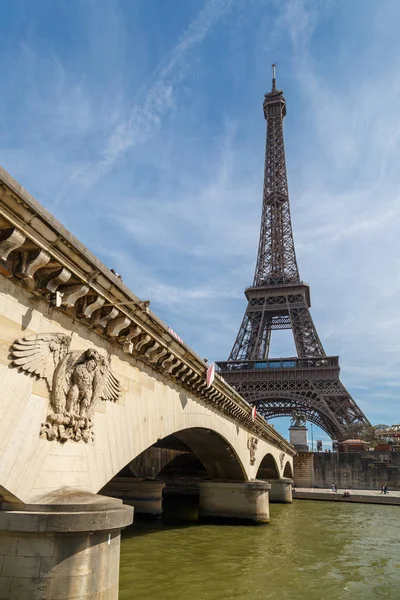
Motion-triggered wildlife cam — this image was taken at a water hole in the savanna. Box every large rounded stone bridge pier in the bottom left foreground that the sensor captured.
[0,491,133,600]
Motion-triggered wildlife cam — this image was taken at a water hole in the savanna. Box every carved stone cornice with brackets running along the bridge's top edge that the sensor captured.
[0,167,296,456]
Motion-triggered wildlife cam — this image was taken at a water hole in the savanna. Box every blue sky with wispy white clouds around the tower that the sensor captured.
[0,0,400,446]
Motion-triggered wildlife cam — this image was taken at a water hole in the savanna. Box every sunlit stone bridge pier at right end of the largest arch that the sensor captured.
[199,480,271,523]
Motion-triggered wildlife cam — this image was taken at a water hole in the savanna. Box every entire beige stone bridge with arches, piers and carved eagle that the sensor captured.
[0,169,295,600]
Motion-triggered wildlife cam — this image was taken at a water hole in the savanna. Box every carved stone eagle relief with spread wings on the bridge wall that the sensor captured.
[11,333,120,442]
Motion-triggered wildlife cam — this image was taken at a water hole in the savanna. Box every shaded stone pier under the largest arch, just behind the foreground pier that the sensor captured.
[101,477,165,517]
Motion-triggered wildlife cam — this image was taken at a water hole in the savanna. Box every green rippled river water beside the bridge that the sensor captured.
[120,500,400,600]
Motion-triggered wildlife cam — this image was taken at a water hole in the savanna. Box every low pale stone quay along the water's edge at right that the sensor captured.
[293,488,400,505]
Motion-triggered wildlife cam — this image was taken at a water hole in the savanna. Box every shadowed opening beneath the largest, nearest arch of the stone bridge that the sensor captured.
[100,427,248,516]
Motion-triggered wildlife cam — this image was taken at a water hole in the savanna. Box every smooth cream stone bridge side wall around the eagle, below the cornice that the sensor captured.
[0,276,292,502]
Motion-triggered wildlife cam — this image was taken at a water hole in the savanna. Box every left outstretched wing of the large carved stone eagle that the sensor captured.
[11,333,71,390]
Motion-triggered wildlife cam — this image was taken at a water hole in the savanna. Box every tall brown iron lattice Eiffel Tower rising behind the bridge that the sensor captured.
[217,65,369,440]
